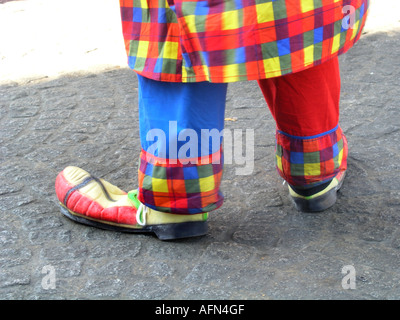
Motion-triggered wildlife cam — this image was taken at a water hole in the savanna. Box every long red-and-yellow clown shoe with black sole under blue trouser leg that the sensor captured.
[55,167,208,240]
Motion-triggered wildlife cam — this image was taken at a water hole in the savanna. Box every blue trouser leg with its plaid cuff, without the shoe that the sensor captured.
[138,76,227,214]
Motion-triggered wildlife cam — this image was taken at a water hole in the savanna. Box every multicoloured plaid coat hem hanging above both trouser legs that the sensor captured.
[120,0,369,82]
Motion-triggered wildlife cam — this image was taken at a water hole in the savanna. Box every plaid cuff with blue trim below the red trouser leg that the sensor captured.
[276,126,347,187]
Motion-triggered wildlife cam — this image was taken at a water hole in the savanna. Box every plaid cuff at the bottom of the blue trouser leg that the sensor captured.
[138,149,223,214]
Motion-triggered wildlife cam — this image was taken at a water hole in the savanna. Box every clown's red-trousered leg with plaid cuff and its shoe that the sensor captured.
[259,58,347,211]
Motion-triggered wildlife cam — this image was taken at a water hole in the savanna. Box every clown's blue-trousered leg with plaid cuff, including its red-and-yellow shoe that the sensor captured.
[55,76,227,240]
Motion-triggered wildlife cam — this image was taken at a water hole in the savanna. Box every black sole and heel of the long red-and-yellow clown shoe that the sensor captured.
[59,202,208,240]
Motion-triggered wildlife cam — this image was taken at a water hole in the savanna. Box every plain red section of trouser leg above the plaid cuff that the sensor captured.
[259,58,340,137]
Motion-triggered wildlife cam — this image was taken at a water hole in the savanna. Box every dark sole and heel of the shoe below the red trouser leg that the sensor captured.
[291,174,344,212]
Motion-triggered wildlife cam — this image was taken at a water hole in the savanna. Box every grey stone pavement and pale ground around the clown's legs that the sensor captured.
[0,0,400,299]
